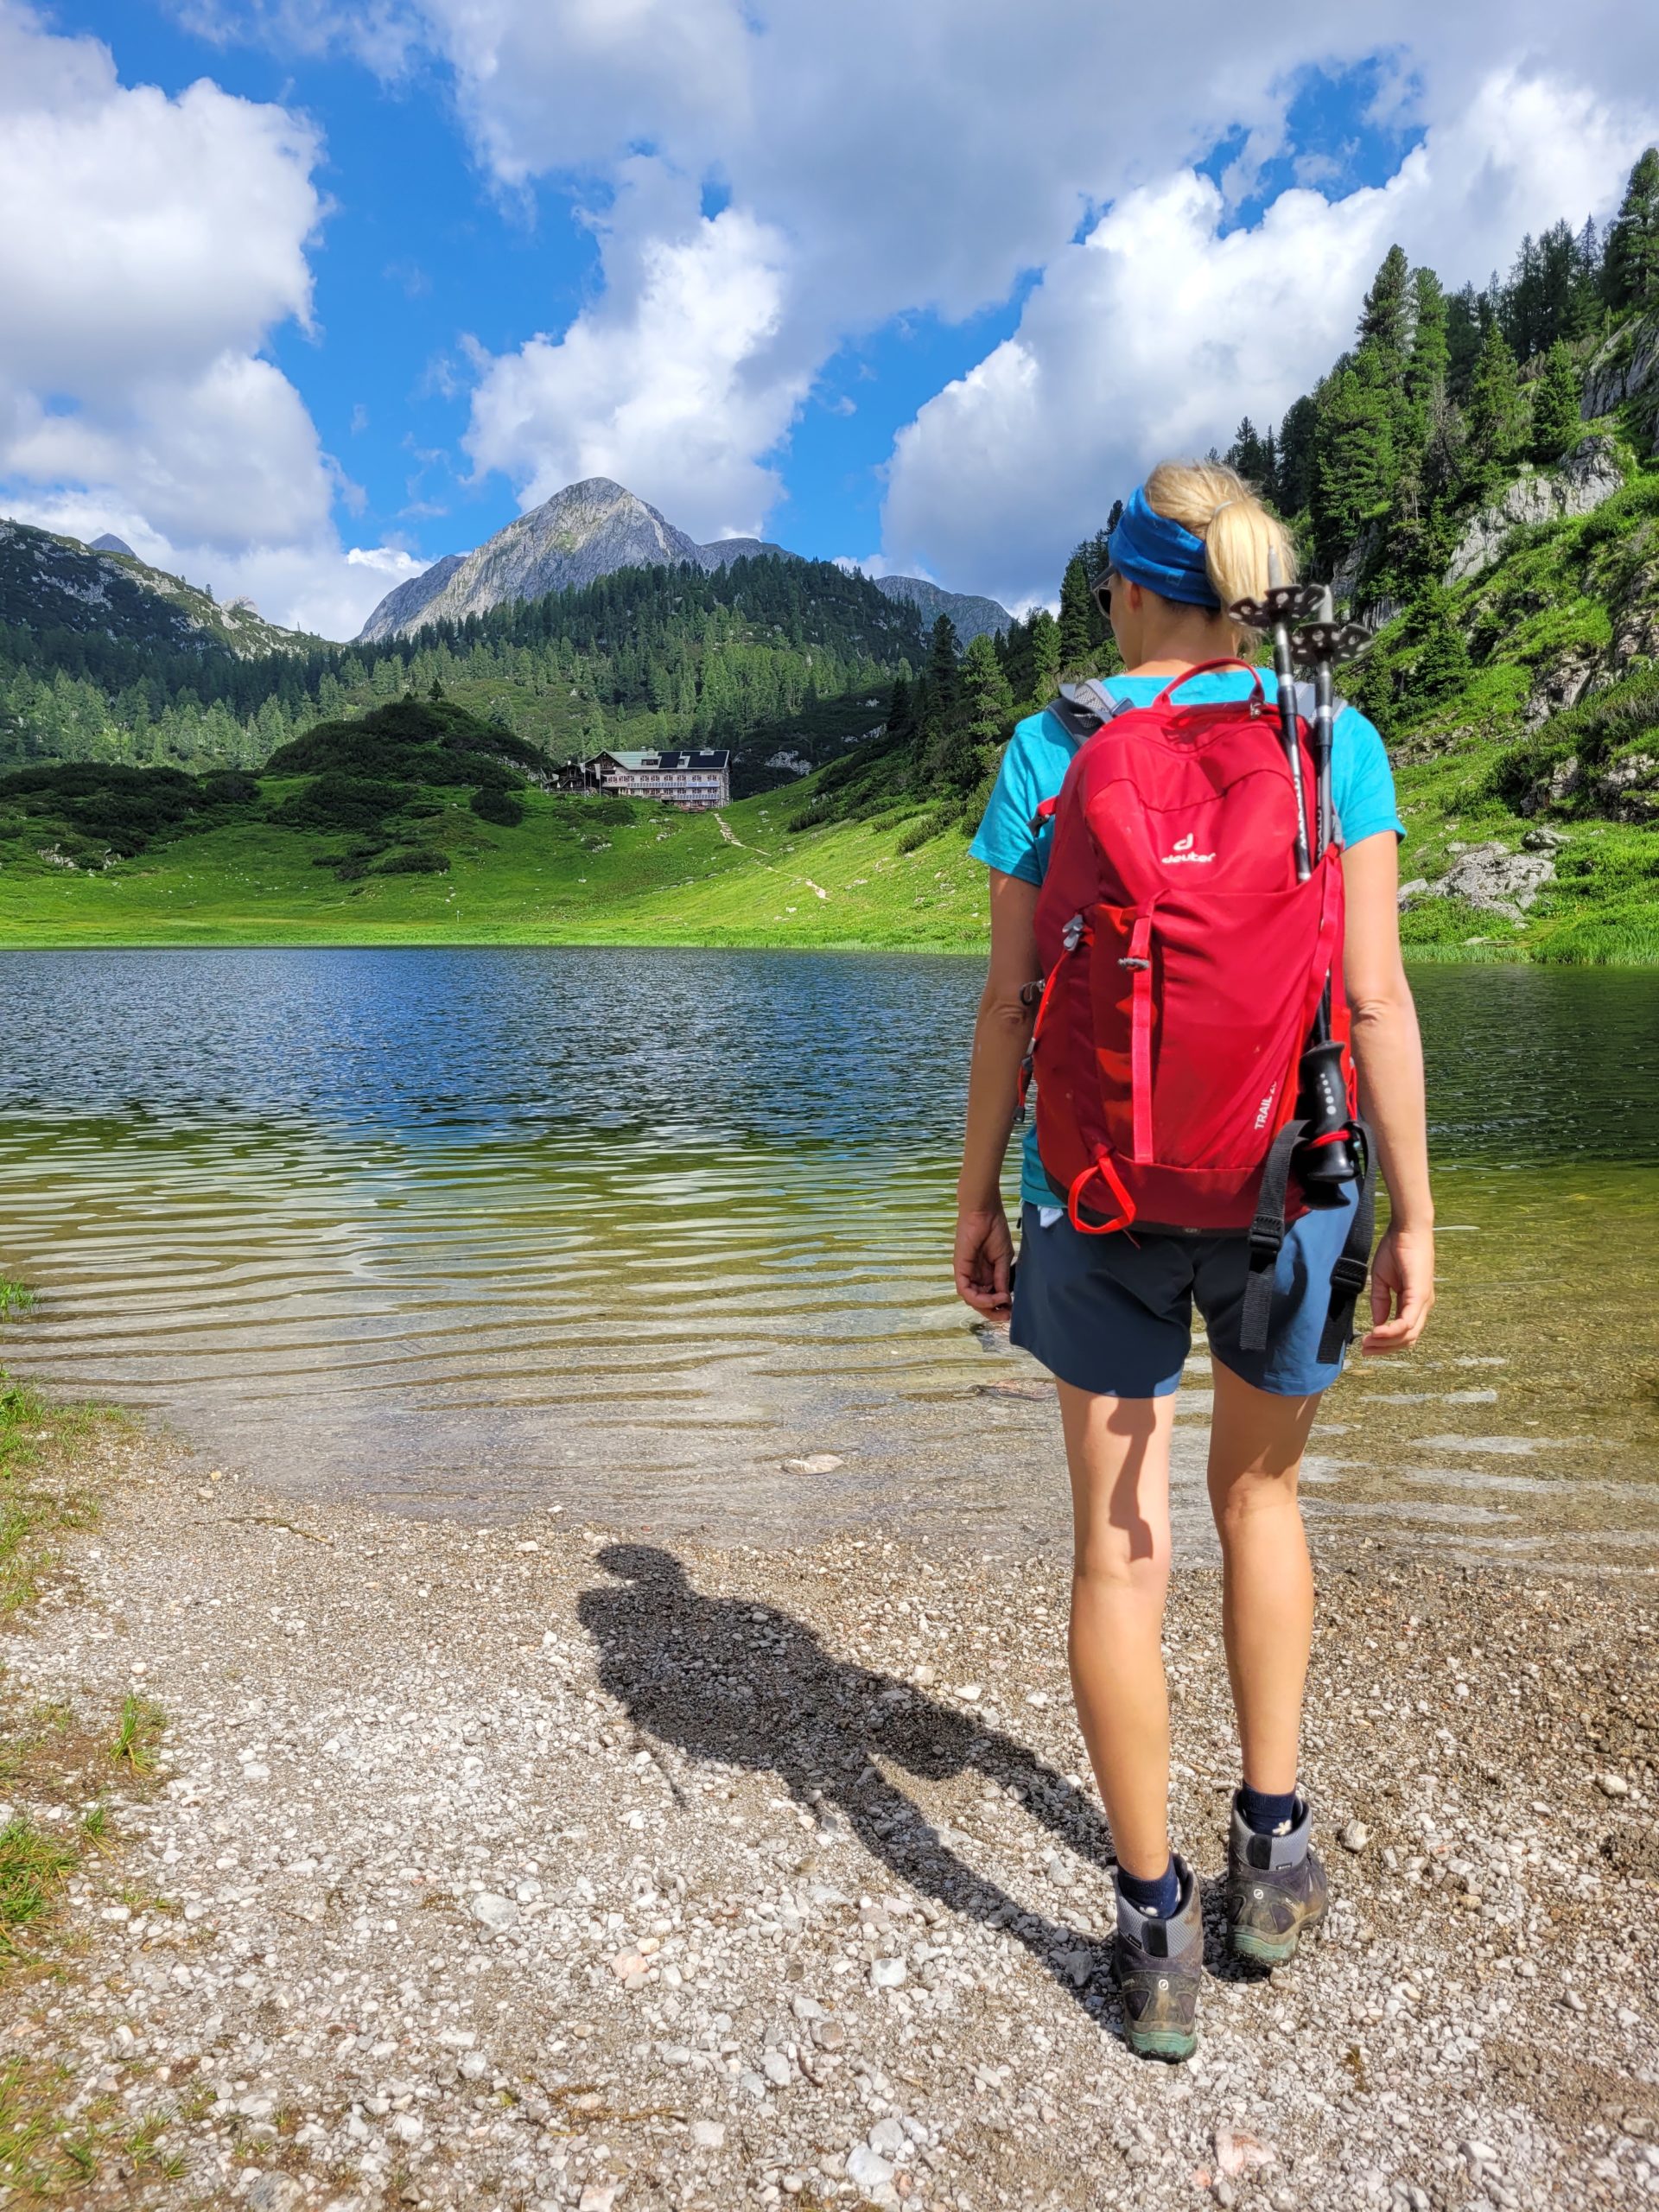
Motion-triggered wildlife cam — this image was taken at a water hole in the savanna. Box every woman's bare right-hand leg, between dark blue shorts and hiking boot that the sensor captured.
[1210,1360,1319,1794]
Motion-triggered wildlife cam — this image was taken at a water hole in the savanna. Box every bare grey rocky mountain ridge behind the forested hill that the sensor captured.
[359,475,1013,644]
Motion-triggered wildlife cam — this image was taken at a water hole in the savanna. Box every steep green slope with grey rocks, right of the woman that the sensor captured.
[1350,447,1659,963]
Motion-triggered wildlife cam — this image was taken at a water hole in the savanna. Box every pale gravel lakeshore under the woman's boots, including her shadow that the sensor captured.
[0,1438,1659,2212]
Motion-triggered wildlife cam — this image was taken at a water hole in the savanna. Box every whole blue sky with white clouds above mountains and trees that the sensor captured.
[0,0,1659,635]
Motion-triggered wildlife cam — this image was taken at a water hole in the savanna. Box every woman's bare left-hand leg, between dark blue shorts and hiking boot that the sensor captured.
[1058,1382,1174,1883]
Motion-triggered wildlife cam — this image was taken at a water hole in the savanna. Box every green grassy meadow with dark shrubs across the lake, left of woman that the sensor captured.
[0,702,982,947]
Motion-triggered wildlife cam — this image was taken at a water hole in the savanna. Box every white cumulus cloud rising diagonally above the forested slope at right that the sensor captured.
[882,71,1652,604]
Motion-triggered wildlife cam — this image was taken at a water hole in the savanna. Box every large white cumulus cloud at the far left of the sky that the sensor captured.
[0,0,429,635]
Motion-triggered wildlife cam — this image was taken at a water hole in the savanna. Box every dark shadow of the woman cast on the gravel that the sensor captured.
[577,1544,1113,2013]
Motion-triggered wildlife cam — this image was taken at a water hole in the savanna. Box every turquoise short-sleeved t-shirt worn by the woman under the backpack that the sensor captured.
[969,668,1405,1205]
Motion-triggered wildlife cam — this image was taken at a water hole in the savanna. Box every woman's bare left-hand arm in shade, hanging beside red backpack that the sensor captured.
[956,869,1042,1314]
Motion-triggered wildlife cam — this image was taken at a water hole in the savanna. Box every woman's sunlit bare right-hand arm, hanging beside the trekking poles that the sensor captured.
[1343,830,1433,1351]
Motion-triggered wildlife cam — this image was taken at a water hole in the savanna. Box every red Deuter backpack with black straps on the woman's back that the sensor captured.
[1020,661,1371,1358]
